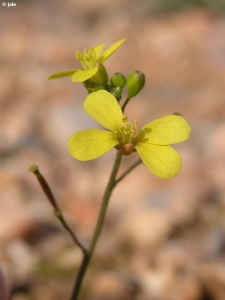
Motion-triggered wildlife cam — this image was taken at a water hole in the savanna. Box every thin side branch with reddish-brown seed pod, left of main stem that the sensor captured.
[29,165,86,254]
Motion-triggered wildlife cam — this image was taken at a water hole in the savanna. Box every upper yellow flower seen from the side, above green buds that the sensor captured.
[48,39,126,82]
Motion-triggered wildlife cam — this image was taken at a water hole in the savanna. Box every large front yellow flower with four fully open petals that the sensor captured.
[68,90,190,178]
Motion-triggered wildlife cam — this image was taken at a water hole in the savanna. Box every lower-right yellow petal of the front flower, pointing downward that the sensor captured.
[135,142,181,178]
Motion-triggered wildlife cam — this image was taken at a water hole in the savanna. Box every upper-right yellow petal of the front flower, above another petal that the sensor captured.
[141,115,191,145]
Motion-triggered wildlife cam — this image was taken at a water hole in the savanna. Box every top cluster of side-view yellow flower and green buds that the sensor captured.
[48,38,145,106]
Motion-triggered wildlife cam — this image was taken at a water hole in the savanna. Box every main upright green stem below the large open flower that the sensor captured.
[71,152,122,300]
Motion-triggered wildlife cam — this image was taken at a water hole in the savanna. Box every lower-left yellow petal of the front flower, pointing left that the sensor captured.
[68,129,118,161]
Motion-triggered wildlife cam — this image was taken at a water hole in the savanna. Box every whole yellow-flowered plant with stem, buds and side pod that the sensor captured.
[30,39,191,300]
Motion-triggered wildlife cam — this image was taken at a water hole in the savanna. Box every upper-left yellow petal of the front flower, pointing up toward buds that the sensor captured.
[83,90,124,132]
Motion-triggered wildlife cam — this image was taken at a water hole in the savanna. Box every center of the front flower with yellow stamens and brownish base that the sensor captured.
[116,118,137,155]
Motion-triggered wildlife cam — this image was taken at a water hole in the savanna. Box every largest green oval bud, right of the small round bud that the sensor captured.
[126,71,145,98]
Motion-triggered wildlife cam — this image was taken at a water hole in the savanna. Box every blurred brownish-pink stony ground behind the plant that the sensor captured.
[0,0,225,300]
